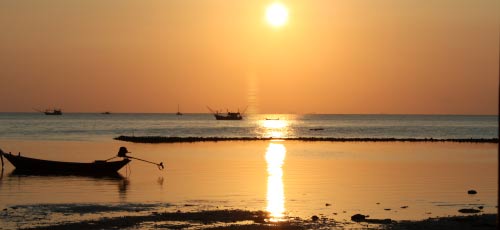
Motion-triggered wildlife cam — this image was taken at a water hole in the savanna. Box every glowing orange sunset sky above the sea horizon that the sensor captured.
[0,0,500,114]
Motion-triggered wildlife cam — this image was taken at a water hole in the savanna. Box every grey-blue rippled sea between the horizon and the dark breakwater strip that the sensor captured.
[0,113,498,141]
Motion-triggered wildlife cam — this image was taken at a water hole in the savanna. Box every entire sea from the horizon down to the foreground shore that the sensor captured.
[0,113,498,229]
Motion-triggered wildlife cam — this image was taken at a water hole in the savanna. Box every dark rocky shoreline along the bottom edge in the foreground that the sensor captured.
[8,209,497,230]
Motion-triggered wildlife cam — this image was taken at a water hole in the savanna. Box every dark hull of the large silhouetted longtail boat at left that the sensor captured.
[3,154,130,175]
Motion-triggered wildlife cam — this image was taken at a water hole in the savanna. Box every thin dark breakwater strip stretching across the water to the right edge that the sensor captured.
[113,135,498,144]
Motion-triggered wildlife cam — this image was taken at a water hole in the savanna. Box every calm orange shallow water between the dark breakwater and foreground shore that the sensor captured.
[0,140,498,227]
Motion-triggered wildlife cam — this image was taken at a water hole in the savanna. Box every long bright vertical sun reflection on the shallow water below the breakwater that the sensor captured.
[266,142,286,222]
